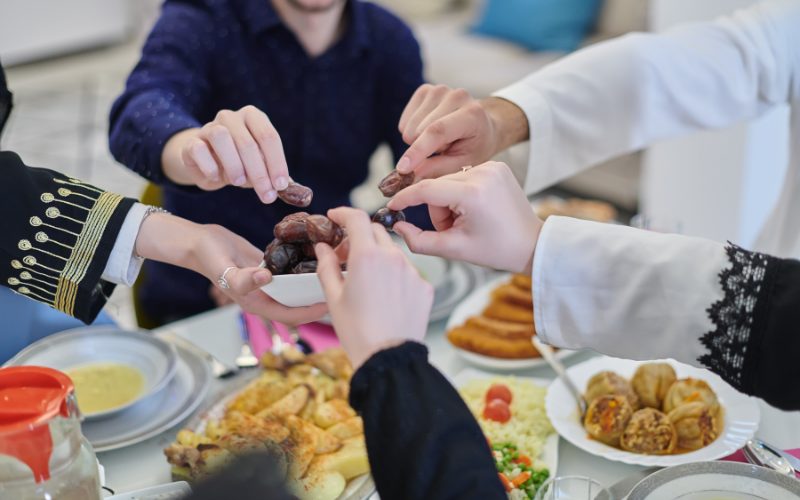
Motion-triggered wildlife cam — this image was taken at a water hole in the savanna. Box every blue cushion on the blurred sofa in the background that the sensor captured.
[473,0,601,51]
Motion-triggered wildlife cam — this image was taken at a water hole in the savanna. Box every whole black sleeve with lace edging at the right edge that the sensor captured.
[699,244,800,410]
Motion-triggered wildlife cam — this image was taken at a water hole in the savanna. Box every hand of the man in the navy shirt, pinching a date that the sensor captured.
[161,106,289,203]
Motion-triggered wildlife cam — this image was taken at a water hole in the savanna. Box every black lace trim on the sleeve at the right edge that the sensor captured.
[698,242,781,394]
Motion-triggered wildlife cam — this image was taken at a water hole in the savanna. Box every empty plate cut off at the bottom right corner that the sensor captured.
[628,462,800,500]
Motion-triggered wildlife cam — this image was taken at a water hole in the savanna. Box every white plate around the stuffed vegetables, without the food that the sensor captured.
[545,356,761,467]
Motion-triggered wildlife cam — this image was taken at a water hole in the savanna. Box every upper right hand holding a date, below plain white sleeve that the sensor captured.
[397,84,528,179]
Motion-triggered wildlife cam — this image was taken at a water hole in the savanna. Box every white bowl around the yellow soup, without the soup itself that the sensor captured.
[5,326,178,420]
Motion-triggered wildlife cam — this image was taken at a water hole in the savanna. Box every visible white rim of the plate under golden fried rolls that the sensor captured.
[447,274,580,371]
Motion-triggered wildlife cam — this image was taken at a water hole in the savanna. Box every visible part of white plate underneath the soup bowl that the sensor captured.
[81,346,211,452]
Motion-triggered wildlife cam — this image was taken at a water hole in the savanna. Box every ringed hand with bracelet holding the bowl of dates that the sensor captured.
[136,213,328,325]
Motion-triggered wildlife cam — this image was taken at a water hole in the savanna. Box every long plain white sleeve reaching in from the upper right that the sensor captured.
[494,0,800,193]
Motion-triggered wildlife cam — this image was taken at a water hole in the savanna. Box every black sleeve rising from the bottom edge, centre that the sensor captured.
[350,342,507,500]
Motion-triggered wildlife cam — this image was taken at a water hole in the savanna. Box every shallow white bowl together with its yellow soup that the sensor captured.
[5,326,178,420]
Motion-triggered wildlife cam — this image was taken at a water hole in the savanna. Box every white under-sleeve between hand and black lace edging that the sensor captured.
[532,217,731,366]
